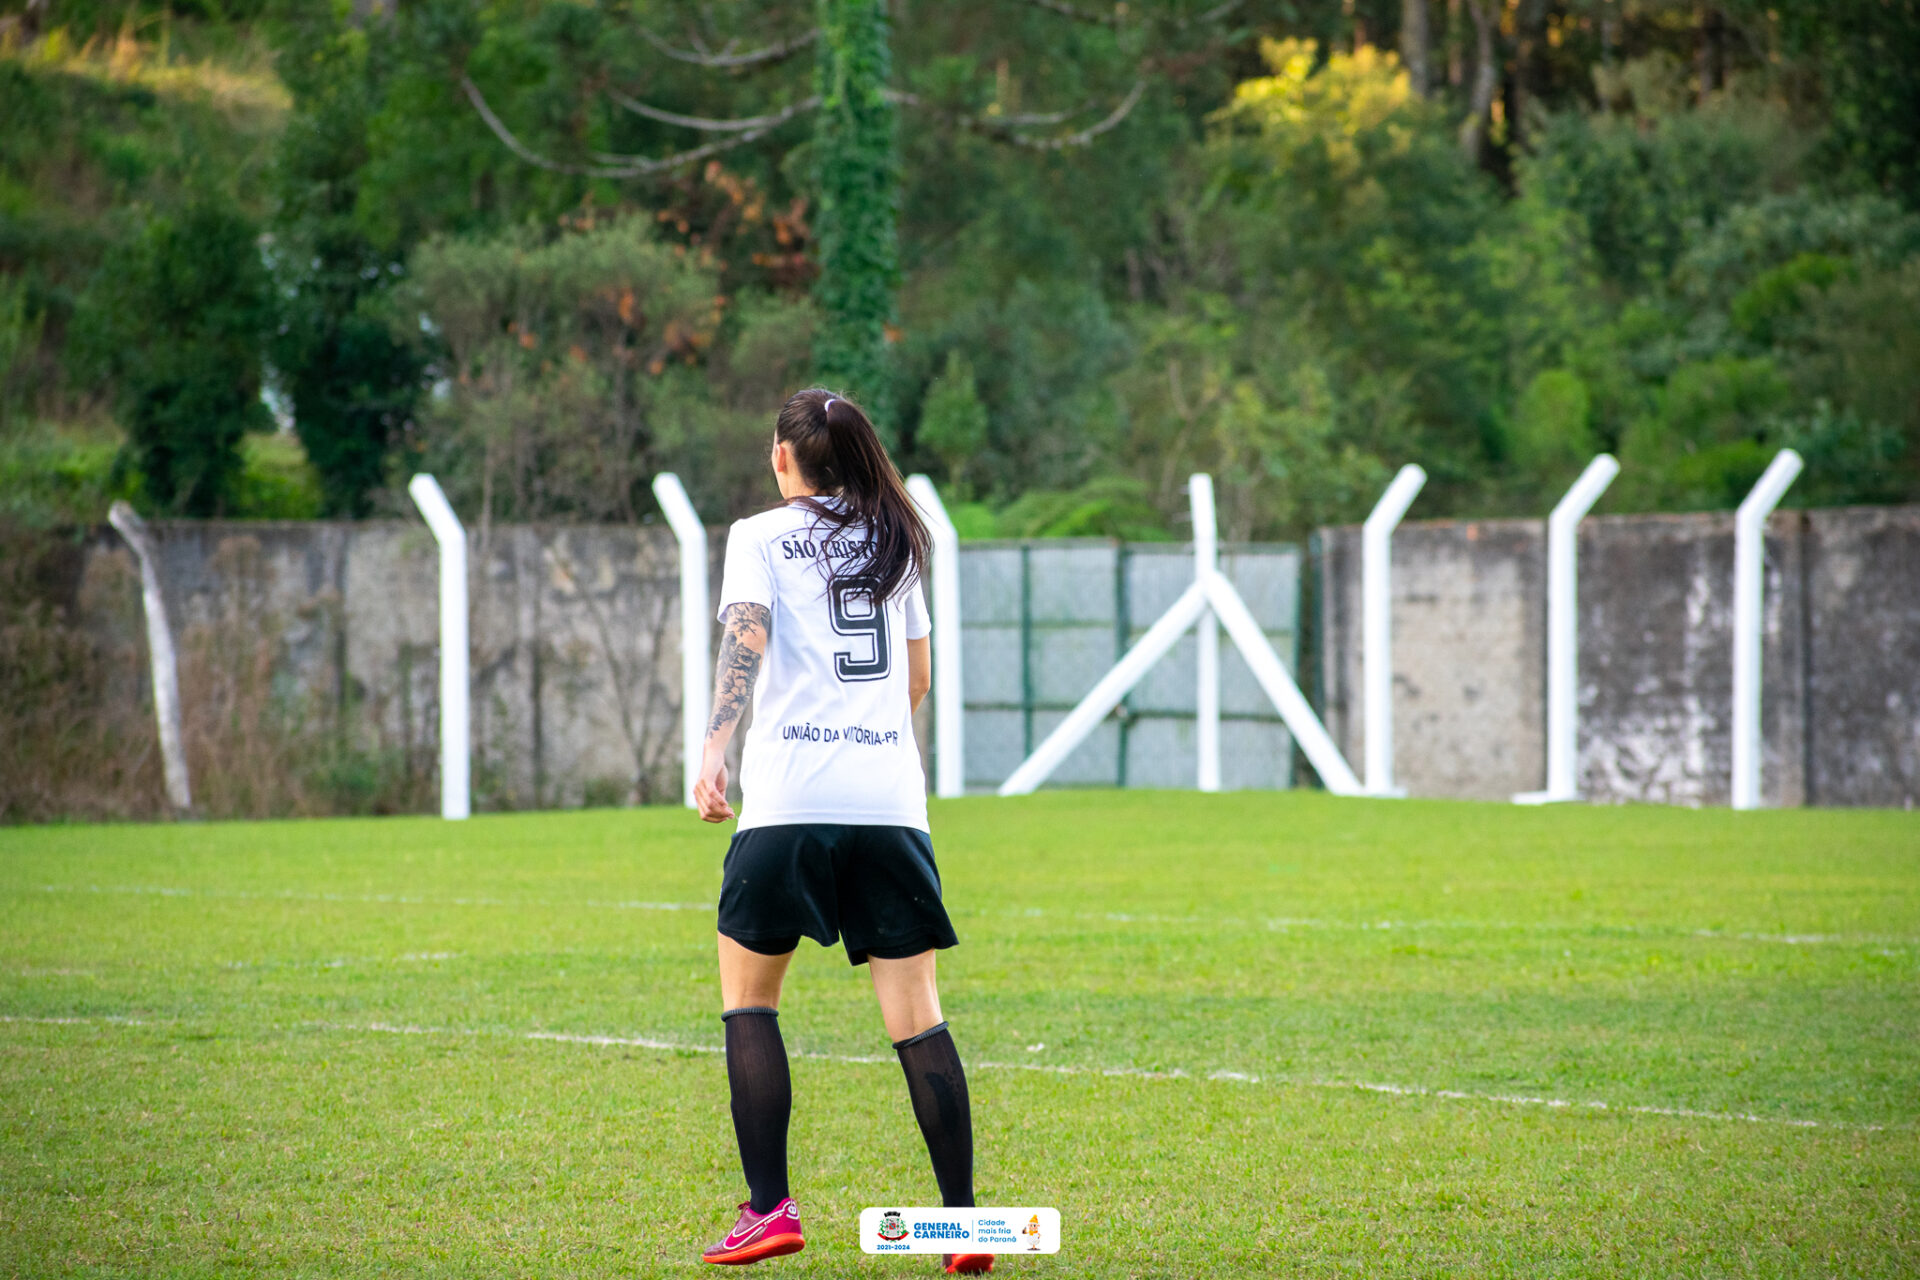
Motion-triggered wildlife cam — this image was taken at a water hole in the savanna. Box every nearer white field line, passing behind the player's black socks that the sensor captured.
[0,1015,1907,1132]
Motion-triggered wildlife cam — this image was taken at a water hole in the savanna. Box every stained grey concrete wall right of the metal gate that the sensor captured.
[1317,507,1920,806]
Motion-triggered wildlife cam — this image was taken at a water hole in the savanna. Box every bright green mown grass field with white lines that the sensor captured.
[0,793,1920,1278]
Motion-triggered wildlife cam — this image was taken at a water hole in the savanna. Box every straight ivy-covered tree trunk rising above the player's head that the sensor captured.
[812,0,900,429]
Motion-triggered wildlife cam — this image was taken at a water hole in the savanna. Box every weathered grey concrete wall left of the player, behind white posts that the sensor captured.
[69,520,726,808]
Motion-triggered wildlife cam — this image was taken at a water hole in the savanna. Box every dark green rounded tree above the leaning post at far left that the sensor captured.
[81,200,273,516]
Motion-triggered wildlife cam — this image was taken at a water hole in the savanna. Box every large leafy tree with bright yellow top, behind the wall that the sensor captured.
[1194,42,1520,518]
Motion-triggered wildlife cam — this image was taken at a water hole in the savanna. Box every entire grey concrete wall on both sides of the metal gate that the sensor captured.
[48,507,1920,806]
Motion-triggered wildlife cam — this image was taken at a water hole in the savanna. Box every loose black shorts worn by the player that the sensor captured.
[720,823,960,965]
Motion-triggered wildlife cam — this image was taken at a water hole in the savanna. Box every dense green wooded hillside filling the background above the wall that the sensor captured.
[0,0,1920,537]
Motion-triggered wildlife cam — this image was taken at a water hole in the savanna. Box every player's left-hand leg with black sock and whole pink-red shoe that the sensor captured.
[703,933,804,1263]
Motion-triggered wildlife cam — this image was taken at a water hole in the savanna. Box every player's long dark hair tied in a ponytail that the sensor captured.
[774,388,931,606]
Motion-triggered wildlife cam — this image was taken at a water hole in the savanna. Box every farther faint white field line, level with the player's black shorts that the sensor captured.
[11,885,1920,960]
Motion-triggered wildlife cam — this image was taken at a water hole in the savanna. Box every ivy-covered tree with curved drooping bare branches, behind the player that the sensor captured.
[459,0,1242,434]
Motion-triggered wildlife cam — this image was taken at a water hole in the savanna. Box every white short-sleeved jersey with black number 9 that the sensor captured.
[720,499,933,831]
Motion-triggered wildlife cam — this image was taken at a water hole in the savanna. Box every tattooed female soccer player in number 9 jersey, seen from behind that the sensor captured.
[693,390,993,1274]
